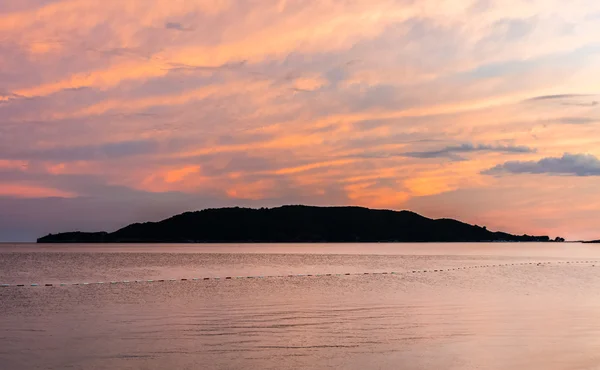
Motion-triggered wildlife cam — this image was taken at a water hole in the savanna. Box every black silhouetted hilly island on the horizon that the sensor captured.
[38,206,550,243]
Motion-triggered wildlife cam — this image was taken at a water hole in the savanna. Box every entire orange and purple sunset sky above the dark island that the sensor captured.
[0,0,600,241]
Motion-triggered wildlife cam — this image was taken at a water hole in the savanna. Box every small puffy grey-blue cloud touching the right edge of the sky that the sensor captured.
[482,153,600,176]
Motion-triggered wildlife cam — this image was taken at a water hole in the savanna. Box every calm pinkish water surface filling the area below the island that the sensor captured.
[0,243,600,370]
